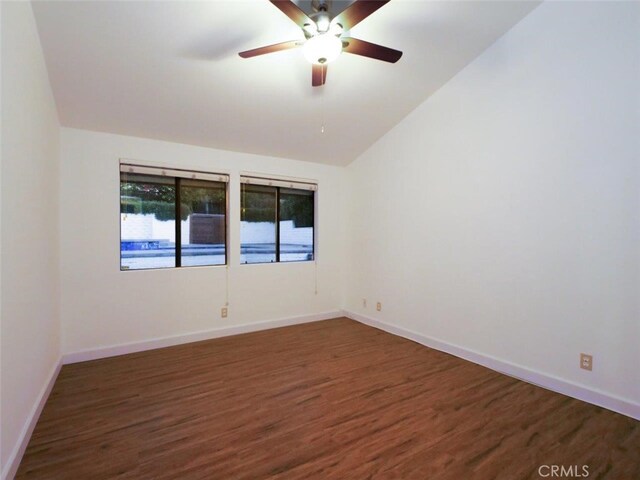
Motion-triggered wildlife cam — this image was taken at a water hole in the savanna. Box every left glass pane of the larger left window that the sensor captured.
[120,173,176,270]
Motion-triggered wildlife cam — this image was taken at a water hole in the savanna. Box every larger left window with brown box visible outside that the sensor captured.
[120,164,228,270]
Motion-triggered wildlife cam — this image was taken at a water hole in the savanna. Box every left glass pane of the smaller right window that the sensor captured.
[240,183,277,263]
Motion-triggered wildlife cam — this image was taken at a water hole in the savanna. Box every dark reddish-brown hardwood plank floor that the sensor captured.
[16,319,640,480]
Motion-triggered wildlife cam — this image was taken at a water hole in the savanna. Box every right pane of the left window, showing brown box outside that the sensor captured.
[180,179,227,267]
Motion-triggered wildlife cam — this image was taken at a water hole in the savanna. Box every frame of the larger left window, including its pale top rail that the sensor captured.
[118,163,230,272]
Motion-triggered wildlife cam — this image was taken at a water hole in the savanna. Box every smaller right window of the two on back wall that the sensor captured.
[240,176,317,263]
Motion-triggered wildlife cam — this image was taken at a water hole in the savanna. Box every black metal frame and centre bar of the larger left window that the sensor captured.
[118,171,229,272]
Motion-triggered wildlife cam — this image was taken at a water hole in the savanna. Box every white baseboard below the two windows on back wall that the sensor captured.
[62,310,342,365]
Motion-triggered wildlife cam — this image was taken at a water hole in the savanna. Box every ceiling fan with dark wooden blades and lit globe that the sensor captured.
[239,0,402,87]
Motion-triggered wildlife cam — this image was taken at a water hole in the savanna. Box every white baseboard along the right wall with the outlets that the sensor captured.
[343,310,640,420]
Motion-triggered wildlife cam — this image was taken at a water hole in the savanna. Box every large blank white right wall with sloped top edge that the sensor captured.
[347,2,640,404]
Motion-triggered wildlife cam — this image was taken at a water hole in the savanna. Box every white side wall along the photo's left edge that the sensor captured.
[0,2,60,476]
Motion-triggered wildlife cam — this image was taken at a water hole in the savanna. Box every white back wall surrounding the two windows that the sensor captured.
[60,128,344,353]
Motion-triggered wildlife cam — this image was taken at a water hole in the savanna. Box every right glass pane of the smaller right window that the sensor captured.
[280,188,314,262]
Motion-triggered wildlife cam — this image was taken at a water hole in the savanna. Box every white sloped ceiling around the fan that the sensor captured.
[33,0,539,165]
